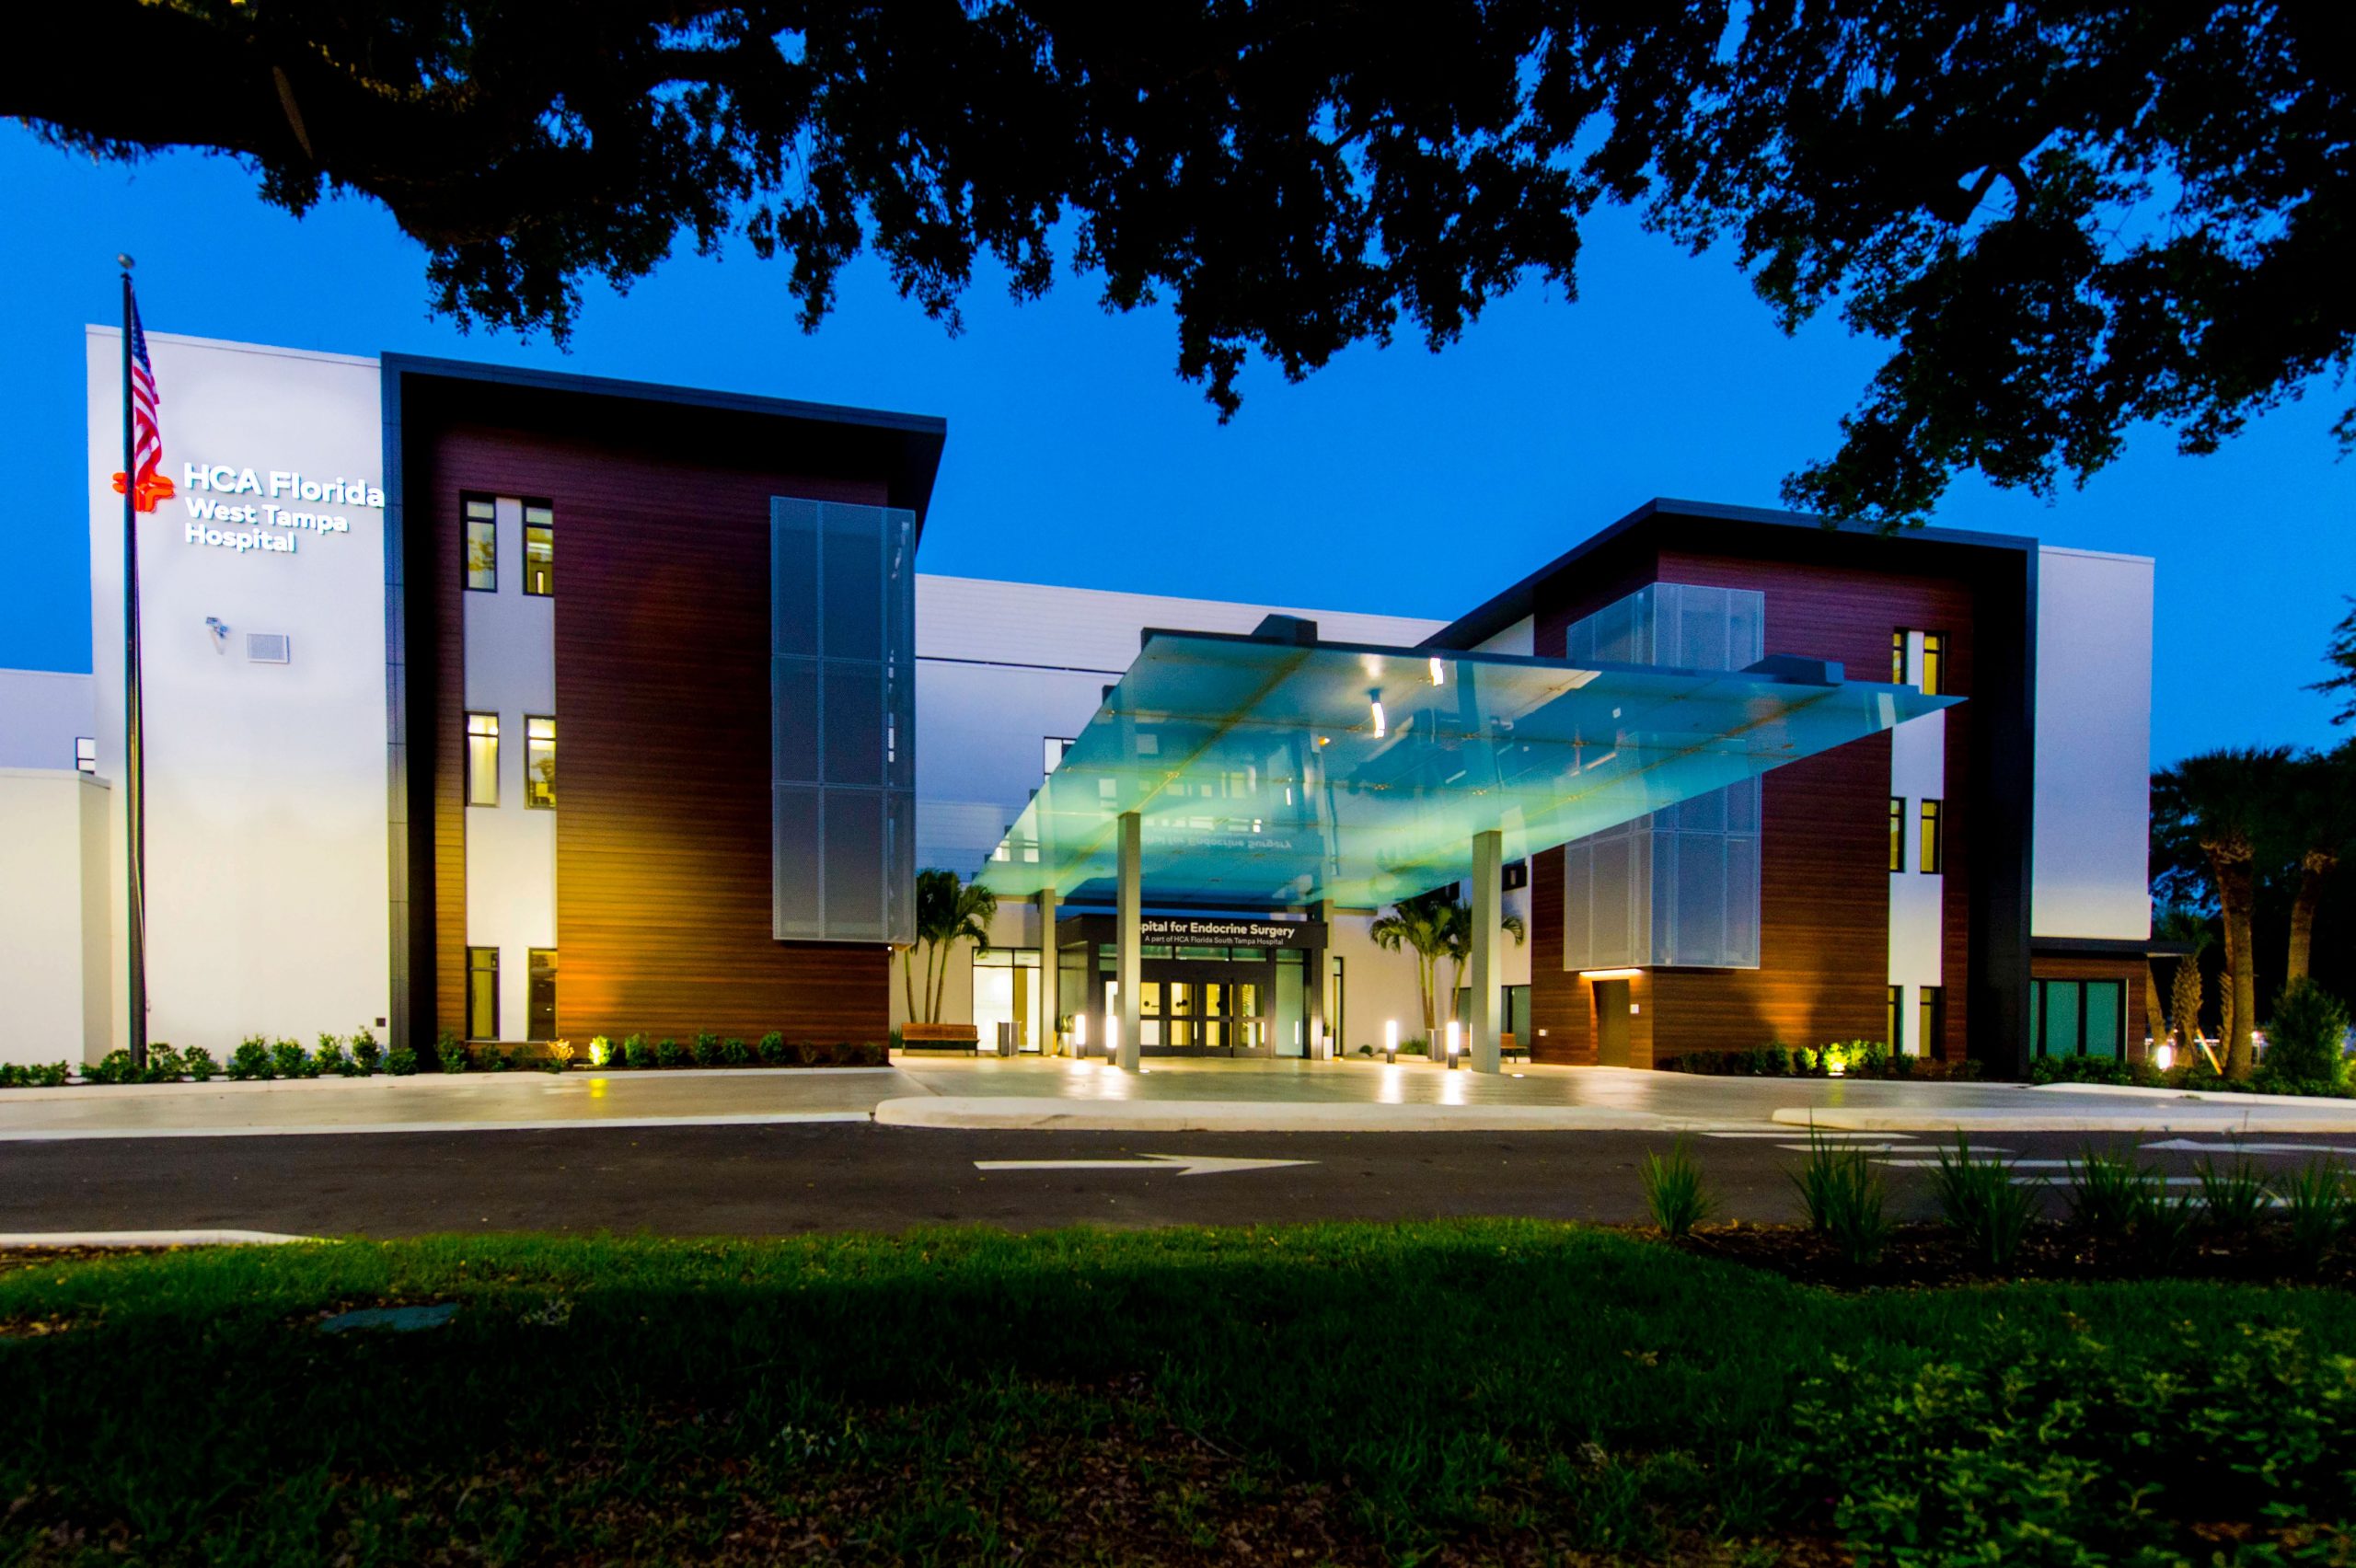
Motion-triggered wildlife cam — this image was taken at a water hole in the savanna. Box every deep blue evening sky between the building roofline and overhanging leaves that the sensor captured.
[0,125,2356,763]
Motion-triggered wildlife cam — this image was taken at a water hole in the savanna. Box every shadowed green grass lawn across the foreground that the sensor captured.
[0,1222,2356,1563]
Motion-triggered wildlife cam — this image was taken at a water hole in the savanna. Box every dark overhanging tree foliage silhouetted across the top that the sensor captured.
[14,0,2356,525]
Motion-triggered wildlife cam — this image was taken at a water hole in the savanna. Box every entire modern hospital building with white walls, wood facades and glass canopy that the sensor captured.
[0,328,2154,1076]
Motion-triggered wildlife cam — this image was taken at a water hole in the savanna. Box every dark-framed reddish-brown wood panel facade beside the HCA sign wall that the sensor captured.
[400,367,938,1041]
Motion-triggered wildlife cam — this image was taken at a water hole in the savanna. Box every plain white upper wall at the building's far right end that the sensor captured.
[2028,547,2151,940]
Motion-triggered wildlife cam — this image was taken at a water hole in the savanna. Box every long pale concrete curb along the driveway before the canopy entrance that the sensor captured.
[874,1095,1760,1133]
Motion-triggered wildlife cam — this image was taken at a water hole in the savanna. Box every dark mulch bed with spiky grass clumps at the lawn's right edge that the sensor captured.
[1668,1222,2356,1290]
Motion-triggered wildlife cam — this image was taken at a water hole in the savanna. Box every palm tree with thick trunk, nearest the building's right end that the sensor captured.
[2151,746,2290,1078]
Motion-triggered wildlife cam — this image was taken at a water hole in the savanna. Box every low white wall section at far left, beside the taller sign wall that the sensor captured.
[0,767,118,1064]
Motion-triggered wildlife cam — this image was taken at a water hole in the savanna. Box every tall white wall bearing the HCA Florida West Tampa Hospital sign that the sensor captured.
[87,328,391,1055]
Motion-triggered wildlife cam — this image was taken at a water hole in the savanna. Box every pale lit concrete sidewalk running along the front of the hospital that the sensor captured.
[0,1057,2356,1142]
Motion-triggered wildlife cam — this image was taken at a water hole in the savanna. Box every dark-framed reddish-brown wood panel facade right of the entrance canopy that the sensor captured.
[1531,518,2027,1066]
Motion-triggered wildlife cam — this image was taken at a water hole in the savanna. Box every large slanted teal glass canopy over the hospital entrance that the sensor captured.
[980,633,1958,909]
